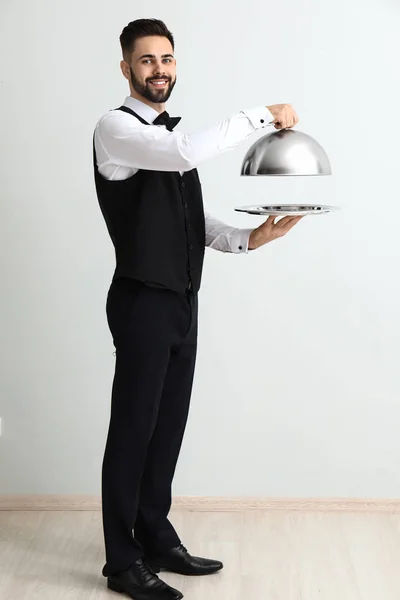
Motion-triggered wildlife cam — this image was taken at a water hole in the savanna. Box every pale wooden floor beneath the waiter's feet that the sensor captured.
[0,510,400,600]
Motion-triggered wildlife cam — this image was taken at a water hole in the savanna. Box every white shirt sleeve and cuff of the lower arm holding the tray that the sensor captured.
[204,210,253,254]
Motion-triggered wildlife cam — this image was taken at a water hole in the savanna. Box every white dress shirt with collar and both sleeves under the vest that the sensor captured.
[94,96,274,254]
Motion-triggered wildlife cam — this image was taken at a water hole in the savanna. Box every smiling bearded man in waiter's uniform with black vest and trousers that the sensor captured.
[94,19,299,600]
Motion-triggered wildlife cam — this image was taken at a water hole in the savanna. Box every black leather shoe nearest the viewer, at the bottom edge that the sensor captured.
[107,558,183,600]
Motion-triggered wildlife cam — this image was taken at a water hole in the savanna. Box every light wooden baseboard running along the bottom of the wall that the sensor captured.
[0,494,400,513]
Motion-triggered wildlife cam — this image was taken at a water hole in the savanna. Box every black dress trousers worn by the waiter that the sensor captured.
[102,279,198,576]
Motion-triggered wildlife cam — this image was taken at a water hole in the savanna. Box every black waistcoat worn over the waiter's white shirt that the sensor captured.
[93,106,206,293]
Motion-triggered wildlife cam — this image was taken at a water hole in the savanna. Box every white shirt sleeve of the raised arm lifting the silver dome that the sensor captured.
[95,106,274,172]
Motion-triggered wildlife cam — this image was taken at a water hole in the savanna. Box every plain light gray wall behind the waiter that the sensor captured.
[0,0,400,497]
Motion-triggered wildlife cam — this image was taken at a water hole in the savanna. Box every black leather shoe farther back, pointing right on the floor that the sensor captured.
[146,544,224,575]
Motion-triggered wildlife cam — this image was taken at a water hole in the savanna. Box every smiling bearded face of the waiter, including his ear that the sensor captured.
[121,36,176,111]
